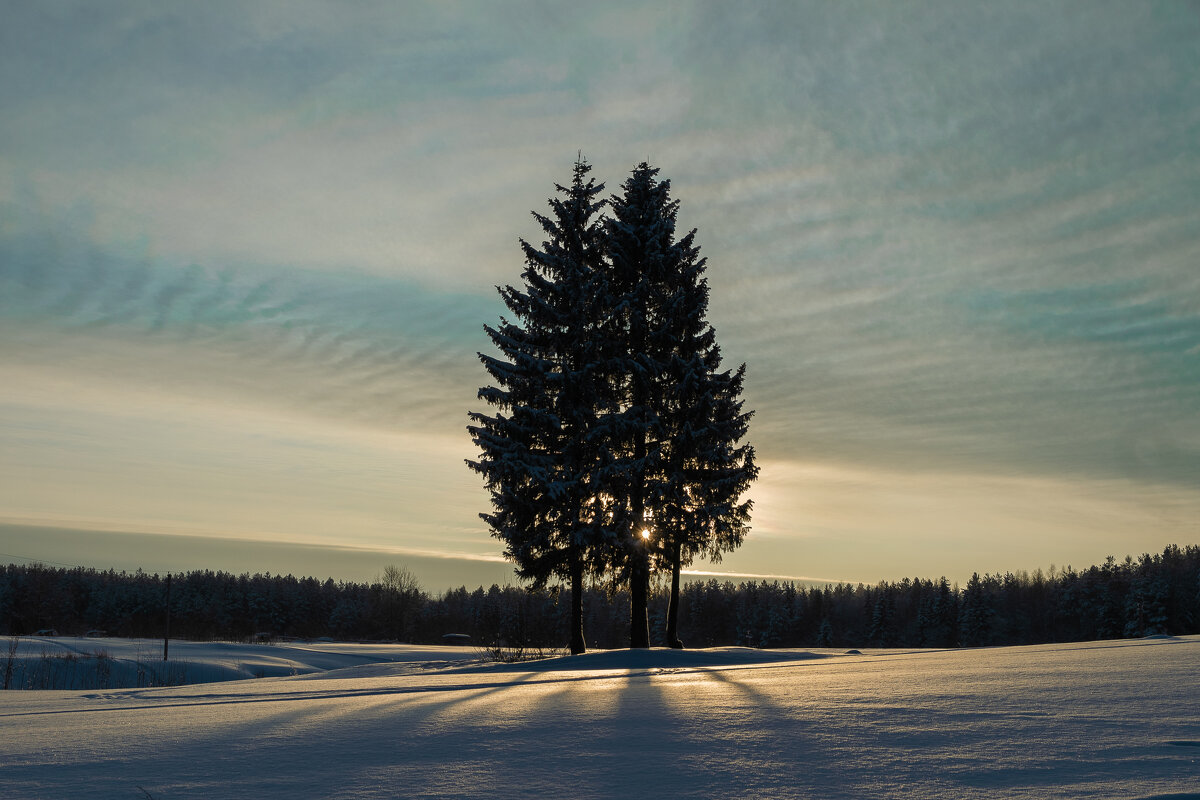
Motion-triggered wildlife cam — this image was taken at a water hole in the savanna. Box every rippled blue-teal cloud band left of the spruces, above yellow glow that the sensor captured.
[0,212,499,429]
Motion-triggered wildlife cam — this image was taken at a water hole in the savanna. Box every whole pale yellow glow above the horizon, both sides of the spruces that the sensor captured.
[0,367,1200,583]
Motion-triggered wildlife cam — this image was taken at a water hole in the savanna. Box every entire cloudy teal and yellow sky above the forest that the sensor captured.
[0,0,1200,590]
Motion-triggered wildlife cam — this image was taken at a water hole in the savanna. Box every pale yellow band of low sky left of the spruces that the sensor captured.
[0,369,489,559]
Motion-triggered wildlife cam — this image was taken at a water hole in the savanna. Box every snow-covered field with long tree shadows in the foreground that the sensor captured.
[0,637,1200,800]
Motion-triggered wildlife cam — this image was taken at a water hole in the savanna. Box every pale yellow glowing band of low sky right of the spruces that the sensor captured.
[739,461,1200,583]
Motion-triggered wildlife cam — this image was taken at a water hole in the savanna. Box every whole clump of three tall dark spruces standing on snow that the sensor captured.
[468,160,757,651]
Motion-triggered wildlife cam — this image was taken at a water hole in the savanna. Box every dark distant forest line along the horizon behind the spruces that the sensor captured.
[0,545,1200,650]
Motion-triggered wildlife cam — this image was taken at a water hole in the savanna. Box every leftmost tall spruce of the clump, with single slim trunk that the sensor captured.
[467,157,617,652]
